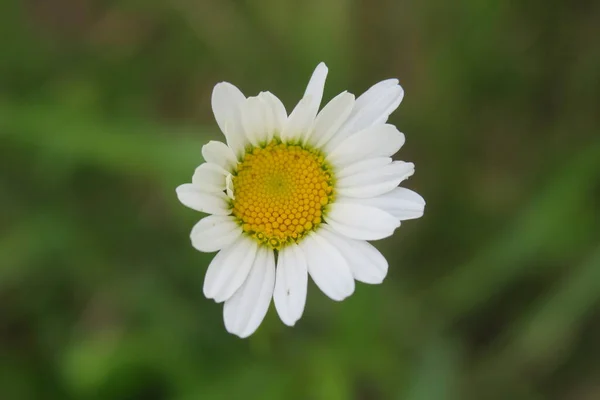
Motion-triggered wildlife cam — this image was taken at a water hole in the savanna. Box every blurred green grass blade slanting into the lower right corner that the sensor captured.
[470,247,600,389]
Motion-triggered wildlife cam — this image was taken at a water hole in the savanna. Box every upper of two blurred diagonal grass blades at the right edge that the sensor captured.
[432,142,600,320]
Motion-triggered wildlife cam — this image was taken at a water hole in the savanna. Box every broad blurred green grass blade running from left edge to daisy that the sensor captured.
[0,102,207,183]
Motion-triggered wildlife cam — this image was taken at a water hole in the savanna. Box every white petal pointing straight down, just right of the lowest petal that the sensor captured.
[273,244,308,326]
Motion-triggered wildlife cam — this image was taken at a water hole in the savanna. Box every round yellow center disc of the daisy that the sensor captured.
[233,140,333,249]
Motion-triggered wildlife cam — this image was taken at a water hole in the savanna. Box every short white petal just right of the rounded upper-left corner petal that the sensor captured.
[241,97,273,146]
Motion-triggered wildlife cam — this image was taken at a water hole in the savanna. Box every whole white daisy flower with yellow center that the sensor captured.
[177,63,425,337]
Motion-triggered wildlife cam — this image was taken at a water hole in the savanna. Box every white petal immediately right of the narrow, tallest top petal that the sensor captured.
[303,92,354,148]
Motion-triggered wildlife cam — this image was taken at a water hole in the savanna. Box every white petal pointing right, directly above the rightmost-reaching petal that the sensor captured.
[336,161,415,198]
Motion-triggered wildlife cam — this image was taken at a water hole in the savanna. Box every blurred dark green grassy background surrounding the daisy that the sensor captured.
[0,0,600,400]
